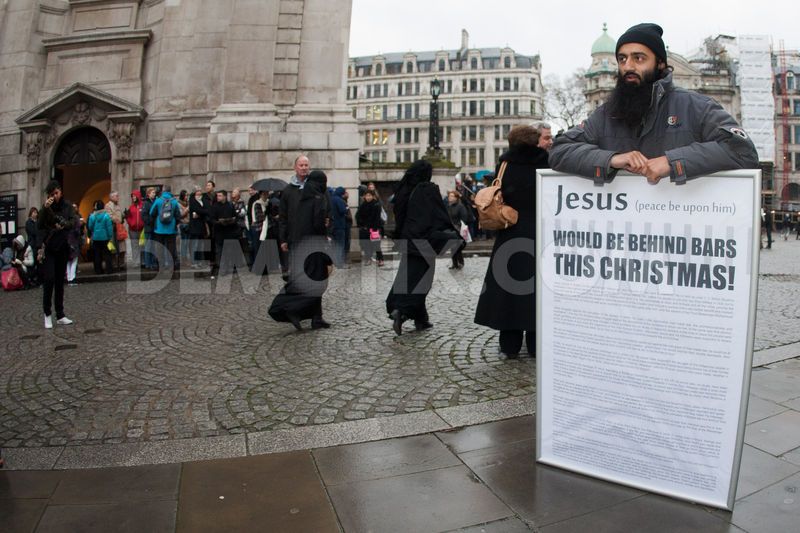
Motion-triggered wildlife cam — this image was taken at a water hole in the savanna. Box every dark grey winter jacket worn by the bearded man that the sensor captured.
[550,73,758,185]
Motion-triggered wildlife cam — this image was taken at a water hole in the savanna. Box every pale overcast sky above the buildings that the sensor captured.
[350,0,800,76]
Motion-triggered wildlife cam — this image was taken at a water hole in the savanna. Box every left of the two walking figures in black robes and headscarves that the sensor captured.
[269,170,333,330]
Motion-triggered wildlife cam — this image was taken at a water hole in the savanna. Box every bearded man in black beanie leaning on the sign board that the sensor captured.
[550,23,758,185]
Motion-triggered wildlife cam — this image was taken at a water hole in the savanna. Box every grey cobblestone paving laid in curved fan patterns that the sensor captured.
[0,240,800,448]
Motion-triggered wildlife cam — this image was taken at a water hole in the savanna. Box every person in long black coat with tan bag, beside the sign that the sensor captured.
[475,126,548,359]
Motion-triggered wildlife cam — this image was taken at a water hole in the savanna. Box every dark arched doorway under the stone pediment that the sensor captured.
[53,127,111,228]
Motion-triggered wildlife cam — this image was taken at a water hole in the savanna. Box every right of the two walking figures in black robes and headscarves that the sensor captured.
[386,160,463,335]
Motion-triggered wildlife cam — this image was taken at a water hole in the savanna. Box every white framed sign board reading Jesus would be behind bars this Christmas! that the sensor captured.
[536,170,761,509]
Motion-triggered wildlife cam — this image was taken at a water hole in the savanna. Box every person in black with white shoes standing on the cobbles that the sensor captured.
[39,180,78,329]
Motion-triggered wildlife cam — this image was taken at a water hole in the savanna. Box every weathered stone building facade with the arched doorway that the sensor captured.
[0,0,359,224]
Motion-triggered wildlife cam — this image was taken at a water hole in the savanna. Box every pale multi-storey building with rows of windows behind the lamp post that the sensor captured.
[347,30,544,179]
